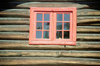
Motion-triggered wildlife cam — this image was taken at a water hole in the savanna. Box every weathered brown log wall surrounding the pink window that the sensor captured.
[0,0,100,66]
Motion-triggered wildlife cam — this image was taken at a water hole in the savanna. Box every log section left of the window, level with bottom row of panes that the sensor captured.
[0,32,29,40]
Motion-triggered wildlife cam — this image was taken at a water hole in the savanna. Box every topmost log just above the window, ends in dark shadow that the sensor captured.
[0,2,100,9]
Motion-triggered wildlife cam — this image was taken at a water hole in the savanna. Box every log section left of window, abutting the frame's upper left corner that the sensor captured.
[0,9,29,17]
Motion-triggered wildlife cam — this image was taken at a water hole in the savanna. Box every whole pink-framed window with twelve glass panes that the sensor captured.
[29,7,76,45]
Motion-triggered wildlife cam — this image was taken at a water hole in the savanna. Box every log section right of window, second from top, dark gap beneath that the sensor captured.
[77,16,100,26]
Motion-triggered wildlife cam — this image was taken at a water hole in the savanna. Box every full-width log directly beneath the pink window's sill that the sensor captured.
[0,40,100,50]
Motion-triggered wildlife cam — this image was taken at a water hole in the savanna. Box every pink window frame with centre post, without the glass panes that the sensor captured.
[29,7,76,45]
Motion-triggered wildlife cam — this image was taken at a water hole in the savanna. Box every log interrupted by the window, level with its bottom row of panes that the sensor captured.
[0,32,100,40]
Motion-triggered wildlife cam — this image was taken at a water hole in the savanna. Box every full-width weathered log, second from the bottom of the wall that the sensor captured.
[0,50,100,58]
